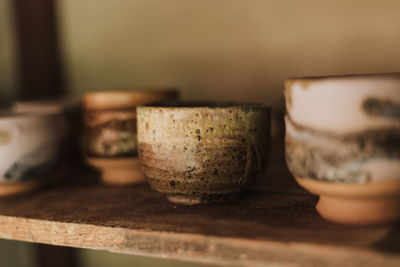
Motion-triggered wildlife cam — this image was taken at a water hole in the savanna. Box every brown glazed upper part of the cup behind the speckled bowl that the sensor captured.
[84,90,178,157]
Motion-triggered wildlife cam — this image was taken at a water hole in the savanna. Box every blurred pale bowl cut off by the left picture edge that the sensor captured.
[0,111,65,196]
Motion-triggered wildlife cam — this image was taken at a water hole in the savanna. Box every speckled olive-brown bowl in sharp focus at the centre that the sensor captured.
[137,103,271,205]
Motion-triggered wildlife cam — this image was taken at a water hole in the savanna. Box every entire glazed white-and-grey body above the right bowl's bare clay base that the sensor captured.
[285,74,400,183]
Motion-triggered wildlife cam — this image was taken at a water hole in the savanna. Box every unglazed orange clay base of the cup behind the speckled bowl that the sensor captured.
[86,157,145,186]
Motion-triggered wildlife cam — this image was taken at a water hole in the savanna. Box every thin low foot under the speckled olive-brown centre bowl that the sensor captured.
[167,193,239,206]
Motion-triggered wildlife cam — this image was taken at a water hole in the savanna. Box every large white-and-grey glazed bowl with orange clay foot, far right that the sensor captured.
[285,74,400,224]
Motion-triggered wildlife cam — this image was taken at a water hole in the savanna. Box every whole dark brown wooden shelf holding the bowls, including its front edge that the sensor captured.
[0,166,400,266]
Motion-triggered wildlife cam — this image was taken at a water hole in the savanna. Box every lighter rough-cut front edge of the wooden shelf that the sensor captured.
[0,216,400,266]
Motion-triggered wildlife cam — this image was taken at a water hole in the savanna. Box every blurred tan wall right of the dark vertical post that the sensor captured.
[58,0,400,109]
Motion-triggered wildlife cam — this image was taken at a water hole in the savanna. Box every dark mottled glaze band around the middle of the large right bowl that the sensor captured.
[285,117,400,183]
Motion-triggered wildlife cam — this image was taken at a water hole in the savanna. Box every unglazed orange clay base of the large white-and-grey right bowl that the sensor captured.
[296,178,400,225]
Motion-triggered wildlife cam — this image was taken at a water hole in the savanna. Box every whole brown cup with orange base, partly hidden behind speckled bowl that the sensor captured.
[83,89,179,185]
